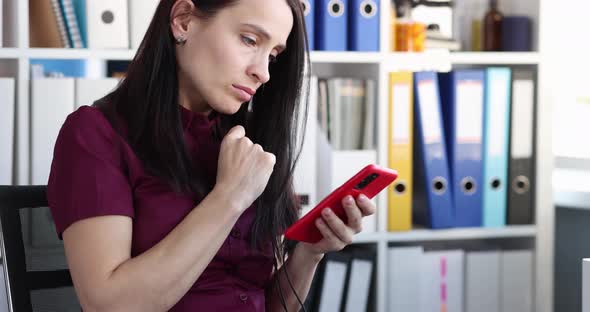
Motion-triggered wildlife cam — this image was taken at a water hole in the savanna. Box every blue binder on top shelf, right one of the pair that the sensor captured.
[348,0,379,51]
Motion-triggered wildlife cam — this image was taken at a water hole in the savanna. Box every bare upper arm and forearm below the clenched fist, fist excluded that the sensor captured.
[63,188,240,312]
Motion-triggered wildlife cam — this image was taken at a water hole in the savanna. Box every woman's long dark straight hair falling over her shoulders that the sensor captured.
[95,0,310,259]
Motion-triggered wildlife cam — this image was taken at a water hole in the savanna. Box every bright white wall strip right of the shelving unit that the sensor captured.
[552,0,590,161]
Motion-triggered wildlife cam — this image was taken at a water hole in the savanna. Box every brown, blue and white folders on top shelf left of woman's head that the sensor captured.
[29,0,159,49]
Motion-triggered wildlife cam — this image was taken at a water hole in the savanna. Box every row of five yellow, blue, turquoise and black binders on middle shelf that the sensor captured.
[388,67,535,231]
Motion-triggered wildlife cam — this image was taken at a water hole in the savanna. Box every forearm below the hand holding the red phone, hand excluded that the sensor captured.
[266,244,323,312]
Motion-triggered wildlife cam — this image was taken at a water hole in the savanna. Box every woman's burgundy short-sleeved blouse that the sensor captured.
[47,106,273,312]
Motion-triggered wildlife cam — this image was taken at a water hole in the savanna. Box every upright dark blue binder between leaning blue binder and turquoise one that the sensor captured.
[440,70,485,227]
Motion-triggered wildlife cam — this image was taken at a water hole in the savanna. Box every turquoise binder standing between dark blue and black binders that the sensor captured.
[483,68,518,227]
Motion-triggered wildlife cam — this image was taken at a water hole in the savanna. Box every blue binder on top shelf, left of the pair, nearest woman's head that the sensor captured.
[314,0,348,51]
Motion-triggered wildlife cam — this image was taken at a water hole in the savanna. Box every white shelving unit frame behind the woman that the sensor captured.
[0,0,554,312]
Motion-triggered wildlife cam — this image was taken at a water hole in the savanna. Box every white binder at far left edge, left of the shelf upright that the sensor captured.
[0,78,15,185]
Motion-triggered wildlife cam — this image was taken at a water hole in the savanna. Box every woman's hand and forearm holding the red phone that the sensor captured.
[266,195,376,312]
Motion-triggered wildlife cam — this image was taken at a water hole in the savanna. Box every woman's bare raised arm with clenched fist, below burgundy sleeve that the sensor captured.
[63,126,275,312]
